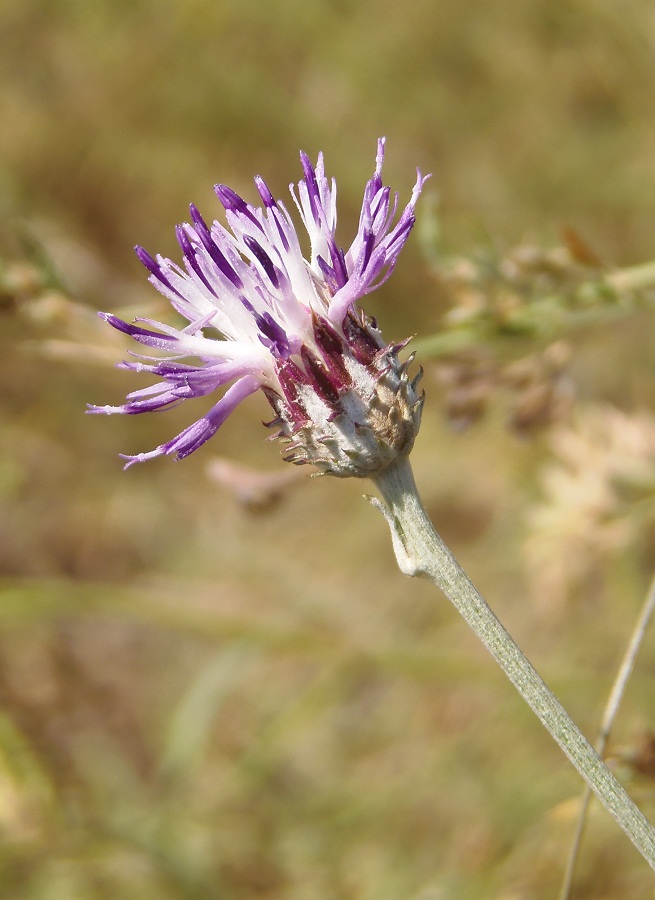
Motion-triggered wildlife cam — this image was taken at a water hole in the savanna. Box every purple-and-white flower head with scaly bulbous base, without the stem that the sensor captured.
[89,138,426,476]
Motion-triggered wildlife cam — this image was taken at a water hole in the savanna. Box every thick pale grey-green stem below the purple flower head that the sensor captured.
[373,458,655,869]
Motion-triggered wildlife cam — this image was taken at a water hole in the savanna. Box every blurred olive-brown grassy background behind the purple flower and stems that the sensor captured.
[0,0,655,900]
